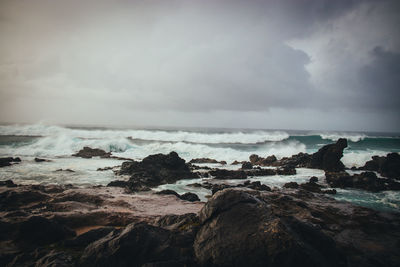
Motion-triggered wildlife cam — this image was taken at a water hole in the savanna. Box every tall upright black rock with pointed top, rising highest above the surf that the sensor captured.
[311,138,347,171]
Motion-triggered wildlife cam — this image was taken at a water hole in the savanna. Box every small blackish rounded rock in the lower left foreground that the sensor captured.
[16,216,75,245]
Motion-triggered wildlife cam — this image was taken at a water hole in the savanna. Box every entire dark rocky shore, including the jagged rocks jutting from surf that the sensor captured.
[0,139,400,267]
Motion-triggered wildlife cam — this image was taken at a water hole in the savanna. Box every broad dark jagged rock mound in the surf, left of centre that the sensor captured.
[118,152,198,191]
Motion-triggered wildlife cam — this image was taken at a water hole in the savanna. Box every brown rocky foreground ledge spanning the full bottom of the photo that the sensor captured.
[0,184,400,267]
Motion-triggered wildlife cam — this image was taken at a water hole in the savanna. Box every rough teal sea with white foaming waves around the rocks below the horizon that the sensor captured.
[0,124,400,215]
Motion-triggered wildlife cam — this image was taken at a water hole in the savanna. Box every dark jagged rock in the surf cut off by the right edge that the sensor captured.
[360,153,400,180]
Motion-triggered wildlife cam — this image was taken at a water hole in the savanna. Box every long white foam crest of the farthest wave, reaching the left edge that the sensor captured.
[0,124,289,144]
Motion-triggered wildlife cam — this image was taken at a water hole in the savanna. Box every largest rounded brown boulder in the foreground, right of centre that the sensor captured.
[194,189,346,266]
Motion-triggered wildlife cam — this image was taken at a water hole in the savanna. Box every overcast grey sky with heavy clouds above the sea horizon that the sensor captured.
[0,0,400,132]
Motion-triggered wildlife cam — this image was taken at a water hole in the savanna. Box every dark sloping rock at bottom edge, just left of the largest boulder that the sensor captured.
[80,223,194,266]
